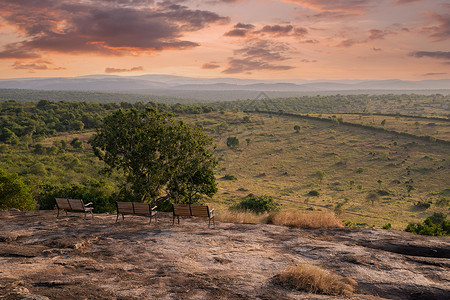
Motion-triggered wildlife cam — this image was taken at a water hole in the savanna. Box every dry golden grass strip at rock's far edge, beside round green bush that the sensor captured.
[270,210,343,228]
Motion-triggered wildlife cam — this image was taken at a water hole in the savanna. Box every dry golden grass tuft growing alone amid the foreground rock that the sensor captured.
[278,264,357,296]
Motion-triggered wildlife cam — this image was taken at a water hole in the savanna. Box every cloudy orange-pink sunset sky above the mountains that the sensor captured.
[0,0,450,80]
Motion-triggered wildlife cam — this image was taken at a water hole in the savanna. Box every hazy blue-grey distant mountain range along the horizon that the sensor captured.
[0,74,450,93]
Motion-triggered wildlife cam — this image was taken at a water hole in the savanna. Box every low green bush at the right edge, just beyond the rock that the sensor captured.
[405,213,450,236]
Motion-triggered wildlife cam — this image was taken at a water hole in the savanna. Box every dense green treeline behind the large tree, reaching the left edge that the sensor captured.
[0,100,212,145]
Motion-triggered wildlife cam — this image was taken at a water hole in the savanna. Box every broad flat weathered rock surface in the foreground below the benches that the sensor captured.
[0,211,450,300]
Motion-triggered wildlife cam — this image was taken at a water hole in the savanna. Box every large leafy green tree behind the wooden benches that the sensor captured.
[90,109,217,203]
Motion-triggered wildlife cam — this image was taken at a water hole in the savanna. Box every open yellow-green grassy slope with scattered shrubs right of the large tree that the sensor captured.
[189,112,450,229]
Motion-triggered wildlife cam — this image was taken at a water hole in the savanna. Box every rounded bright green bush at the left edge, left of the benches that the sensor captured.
[0,169,34,210]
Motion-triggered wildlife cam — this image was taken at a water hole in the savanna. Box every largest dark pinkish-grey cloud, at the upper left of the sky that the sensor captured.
[0,0,229,59]
